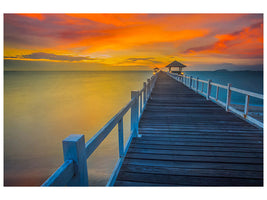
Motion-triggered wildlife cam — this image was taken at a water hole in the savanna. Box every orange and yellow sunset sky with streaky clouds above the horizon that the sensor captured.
[4,14,263,70]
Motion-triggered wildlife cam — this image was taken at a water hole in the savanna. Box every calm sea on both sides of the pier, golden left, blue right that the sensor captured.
[4,71,263,186]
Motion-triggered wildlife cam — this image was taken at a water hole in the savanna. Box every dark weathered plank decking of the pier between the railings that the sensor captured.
[115,72,263,186]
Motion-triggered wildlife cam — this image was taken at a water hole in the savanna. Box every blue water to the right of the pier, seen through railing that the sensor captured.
[185,71,263,106]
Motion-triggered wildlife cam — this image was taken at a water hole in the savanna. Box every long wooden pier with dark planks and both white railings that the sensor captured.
[42,72,263,186]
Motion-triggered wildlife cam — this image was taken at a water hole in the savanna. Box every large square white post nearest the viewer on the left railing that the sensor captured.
[62,134,88,186]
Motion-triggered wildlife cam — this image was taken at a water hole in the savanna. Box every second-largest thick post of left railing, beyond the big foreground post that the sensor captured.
[131,91,139,137]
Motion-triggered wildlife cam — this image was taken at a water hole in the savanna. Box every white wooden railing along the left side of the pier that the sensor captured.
[42,74,157,186]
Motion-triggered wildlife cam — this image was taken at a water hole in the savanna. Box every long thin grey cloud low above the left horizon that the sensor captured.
[21,52,95,62]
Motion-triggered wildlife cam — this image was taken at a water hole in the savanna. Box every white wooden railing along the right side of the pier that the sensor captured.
[167,73,263,128]
